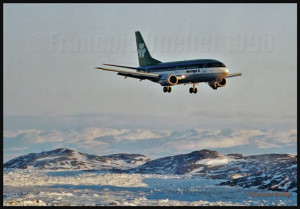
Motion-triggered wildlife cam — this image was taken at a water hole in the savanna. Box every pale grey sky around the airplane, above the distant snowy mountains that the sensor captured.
[3,4,297,130]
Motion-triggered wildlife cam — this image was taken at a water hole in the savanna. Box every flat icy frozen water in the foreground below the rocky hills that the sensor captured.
[3,170,297,206]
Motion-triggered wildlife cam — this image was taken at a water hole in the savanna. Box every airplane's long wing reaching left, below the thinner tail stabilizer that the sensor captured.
[96,67,159,81]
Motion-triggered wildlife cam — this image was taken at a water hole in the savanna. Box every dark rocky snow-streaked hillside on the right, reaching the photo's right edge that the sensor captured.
[129,150,297,192]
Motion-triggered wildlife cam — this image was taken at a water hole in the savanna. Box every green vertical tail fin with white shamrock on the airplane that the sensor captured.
[135,31,160,66]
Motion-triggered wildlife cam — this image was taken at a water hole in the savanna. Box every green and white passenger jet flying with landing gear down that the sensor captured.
[96,31,242,94]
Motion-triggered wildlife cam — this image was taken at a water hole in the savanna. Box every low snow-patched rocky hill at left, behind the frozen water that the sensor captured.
[3,148,150,170]
